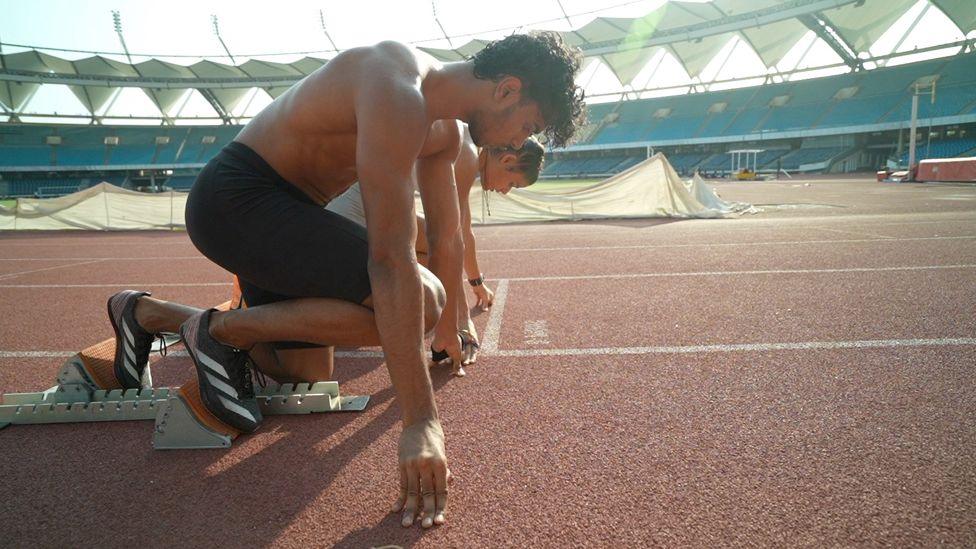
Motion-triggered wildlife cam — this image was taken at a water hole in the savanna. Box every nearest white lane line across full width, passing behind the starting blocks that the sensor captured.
[0,334,976,358]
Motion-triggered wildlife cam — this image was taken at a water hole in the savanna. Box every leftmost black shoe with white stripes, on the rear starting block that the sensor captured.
[108,290,155,389]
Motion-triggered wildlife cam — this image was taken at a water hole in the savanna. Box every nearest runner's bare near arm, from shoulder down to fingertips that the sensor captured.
[356,61,448,527]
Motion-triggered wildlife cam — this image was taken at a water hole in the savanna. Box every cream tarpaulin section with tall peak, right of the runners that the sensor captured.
[470,153,758,224]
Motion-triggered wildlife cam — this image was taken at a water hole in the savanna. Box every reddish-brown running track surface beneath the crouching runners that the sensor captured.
[0,181,976,547]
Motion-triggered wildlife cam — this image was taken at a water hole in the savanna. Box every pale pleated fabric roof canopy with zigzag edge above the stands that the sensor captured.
[0,0,976,123]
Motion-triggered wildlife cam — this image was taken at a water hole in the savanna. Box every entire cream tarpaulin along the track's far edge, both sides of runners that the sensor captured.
[0,153,758,230]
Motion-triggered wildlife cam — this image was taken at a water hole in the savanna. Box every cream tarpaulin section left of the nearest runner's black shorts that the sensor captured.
[0,183,186,230]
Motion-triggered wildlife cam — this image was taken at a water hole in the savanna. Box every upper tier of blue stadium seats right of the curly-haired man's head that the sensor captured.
[589,53,976,145]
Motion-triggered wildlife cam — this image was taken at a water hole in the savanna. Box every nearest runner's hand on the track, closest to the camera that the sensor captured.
[393,418,451,528]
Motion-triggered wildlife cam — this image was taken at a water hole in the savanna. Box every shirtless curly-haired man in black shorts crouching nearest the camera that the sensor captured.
[110,33,583,527]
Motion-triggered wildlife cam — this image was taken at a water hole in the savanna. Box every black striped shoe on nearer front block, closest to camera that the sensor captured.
[180,309,262,433]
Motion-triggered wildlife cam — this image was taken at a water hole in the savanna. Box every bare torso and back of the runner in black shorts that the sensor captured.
[235,42,459,204]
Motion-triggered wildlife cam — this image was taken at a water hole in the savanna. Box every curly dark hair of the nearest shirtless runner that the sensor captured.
[471,31,586,147]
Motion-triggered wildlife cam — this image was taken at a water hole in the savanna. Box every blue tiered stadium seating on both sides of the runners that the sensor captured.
[0,53,976,196]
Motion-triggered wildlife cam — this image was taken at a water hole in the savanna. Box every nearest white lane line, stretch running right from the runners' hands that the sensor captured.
[491,337,976,357]
